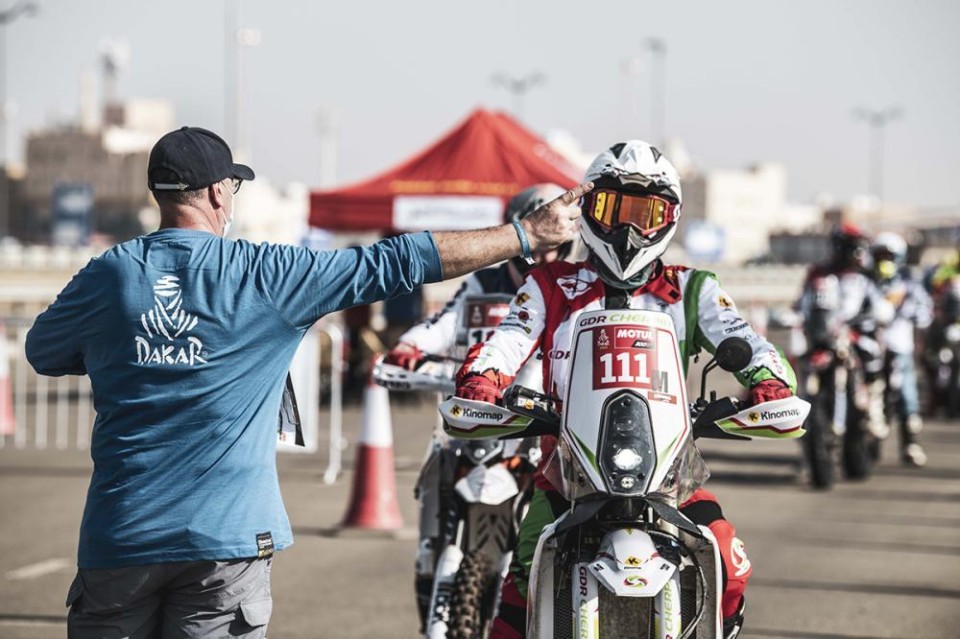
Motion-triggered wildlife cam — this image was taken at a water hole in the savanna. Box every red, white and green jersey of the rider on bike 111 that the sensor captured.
[459,262,796,397]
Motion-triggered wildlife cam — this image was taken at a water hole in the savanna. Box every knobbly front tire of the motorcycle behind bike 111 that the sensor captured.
[447,551,498,639]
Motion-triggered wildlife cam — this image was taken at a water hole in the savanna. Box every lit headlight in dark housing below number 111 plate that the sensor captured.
[600,391,656,495]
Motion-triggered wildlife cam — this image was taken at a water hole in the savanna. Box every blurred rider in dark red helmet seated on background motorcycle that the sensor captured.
[798,223,894,439]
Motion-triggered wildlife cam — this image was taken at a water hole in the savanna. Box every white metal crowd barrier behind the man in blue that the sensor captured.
[0,317,345,472]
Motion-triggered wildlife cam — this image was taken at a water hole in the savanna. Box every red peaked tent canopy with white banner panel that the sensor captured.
[310,109,581,231]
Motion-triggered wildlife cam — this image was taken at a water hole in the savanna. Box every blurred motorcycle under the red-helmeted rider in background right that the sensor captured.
[797,277,880,489]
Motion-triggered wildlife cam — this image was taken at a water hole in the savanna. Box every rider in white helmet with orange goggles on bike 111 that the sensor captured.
[457,140,796,638]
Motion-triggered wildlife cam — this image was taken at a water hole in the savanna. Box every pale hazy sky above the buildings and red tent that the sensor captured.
[7,0,960,206]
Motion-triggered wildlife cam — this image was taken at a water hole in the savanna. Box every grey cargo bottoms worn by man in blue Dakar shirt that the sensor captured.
[67,557,273,639]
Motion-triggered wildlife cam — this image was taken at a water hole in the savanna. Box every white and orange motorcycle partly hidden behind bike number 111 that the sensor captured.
[374,294,541,639]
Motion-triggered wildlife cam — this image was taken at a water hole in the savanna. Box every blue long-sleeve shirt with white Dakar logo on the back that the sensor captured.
[26,229,442,568]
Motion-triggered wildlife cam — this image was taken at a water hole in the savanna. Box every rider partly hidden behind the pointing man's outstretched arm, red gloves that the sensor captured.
[384,183,573,631]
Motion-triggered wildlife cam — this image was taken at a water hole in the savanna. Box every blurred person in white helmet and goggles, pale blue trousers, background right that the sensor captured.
[870,232,933,466]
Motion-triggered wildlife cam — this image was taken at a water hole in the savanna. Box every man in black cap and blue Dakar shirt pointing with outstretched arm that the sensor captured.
[26,127,589,638]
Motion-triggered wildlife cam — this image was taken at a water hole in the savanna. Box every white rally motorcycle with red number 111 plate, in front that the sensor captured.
[441,310,809,639]
